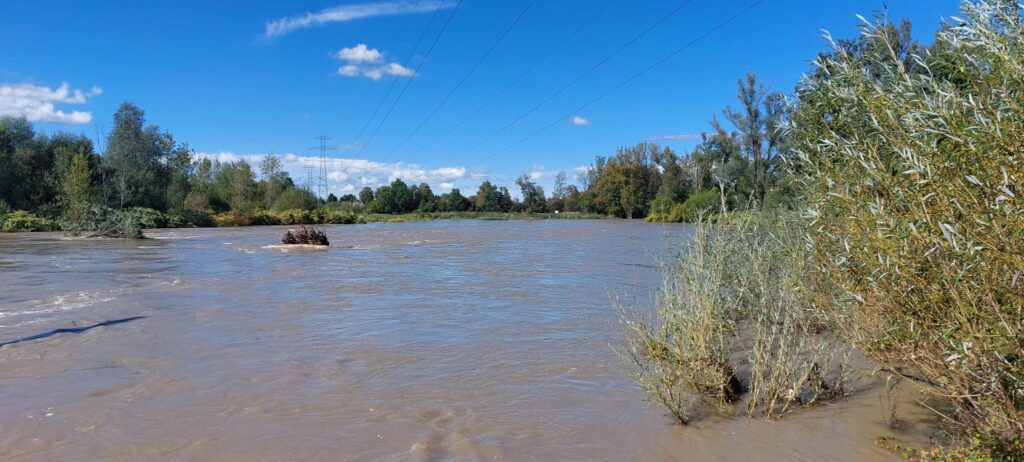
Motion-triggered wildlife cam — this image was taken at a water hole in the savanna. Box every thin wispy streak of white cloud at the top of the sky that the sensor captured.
[264,0,455,38]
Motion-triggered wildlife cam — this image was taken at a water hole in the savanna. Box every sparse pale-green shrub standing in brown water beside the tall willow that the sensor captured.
[623,214,846,423]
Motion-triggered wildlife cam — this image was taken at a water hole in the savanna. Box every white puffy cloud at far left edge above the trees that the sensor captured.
[0,82,103,124]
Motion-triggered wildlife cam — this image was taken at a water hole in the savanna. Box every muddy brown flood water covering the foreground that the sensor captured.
[0,220,937,461]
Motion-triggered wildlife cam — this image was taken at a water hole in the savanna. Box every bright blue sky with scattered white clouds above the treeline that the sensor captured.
[0,0,958,193]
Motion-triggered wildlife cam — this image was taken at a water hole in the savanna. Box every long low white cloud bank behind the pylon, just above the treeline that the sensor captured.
[197,152,476,196]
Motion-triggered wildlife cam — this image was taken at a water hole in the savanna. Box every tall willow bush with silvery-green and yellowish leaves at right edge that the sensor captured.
[790,1,1024,457]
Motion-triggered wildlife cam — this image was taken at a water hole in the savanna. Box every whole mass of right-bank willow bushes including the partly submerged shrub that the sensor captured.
[627,1,1024,460]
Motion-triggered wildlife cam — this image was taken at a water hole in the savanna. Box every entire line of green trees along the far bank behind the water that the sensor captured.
[0,67,793,236]
